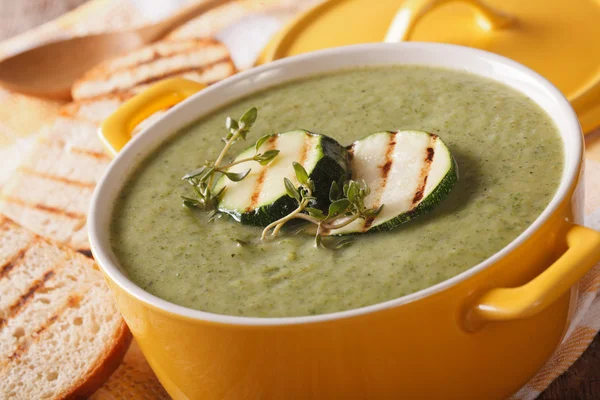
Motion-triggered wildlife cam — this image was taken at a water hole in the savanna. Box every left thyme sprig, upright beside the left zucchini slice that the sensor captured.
[181,107,279,211]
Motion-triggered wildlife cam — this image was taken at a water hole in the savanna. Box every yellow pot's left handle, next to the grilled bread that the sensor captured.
[99,78,206,156]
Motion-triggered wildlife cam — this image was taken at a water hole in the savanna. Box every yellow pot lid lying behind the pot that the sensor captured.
[259,0,600,132]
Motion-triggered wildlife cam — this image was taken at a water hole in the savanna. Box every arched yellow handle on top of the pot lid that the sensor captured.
[384,0,515,43]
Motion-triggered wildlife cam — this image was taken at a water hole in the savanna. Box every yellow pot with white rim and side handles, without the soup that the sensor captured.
[90,43,600,400]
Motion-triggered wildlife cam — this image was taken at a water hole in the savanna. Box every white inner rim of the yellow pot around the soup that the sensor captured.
[89,42,583,326]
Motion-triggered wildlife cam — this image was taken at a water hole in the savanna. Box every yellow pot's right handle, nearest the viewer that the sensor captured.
[469,225,600,321]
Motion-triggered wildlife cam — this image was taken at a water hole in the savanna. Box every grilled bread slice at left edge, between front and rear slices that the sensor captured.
[0,118,110,254]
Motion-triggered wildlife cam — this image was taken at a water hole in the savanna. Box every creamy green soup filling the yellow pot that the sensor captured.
[111,66,563,317]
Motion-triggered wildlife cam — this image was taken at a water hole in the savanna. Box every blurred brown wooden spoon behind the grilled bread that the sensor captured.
[0,0,230,100]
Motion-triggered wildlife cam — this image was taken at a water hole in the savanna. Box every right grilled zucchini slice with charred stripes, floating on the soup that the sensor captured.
[329,131,458,235]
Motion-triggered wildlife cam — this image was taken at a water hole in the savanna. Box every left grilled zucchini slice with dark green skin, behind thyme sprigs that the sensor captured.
[215,130,349,226]
